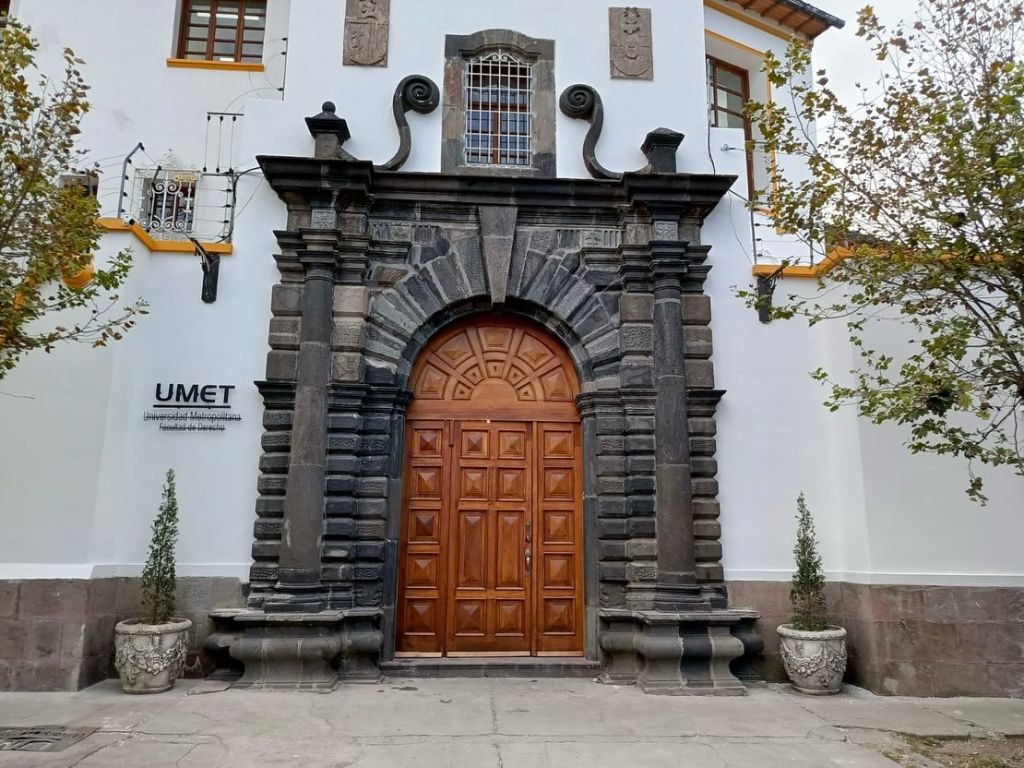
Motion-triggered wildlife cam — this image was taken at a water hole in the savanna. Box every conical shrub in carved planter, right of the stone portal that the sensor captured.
[778,494,846,695]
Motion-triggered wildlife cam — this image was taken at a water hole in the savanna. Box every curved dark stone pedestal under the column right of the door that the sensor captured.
[598,608,758,696]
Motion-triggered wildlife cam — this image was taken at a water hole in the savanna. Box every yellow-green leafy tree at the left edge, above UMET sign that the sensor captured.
[0,18,144,379]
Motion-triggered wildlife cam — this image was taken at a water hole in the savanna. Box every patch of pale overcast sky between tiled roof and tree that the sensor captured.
[810,0,919,104]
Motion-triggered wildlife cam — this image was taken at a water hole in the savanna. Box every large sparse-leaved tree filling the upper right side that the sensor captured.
[742,0,1024,501]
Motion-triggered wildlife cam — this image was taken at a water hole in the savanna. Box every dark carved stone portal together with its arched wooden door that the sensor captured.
[211,99,760,693]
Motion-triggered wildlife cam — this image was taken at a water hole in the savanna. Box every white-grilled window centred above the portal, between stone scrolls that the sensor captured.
[465,50,534,166]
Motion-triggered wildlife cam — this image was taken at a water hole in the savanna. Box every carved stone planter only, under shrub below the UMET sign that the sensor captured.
[114,618,191,693]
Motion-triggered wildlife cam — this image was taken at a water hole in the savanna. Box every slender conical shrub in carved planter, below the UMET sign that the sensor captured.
[114,470,191,693]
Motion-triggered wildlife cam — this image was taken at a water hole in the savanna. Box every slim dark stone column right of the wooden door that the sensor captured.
[651,244,707,611]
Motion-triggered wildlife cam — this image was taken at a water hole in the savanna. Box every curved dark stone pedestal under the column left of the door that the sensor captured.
[210,608,384,690]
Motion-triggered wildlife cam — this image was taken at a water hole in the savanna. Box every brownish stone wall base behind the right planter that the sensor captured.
[728,582,1024,697]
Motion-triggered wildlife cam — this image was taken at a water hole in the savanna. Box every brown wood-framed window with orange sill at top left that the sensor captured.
[178,0,266,63]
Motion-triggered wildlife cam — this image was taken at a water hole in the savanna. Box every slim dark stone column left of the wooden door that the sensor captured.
[265,230,337,611]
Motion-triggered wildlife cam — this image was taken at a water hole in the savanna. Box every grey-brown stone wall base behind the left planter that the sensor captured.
[0,578,245,691]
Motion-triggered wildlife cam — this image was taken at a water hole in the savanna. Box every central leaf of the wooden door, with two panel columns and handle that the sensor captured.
[446,421,532,655]
